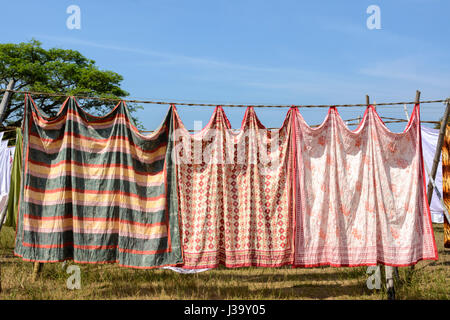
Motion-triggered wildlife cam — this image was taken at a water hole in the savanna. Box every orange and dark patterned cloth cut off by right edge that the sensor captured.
[442,126,450,248]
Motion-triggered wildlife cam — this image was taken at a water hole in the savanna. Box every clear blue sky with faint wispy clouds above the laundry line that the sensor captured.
[0,0,450,132]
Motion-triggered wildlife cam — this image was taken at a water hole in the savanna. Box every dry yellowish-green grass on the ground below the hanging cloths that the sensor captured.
[0,224,450,300]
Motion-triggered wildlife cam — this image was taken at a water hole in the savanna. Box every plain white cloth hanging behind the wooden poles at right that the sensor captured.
[421,127,444,223]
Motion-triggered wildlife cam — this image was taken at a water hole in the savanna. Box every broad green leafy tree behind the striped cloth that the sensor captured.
[0,39,142,128]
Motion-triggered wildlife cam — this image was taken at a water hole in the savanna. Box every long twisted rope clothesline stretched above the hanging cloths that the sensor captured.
[0,89,450,108]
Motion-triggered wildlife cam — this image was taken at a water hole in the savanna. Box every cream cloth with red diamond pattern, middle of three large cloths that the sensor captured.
[174,107,294,269]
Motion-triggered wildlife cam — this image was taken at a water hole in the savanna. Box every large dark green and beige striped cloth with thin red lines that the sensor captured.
[15,96,183,268]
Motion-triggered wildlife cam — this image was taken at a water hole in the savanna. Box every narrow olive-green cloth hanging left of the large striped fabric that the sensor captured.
[5,128,22,229]
